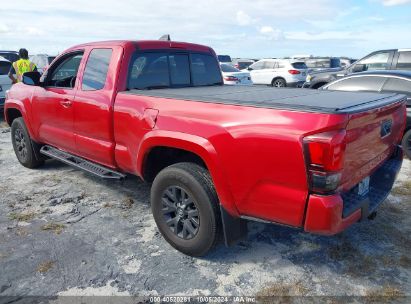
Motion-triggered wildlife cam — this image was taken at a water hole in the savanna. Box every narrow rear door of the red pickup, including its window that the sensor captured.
[74,46,123,167]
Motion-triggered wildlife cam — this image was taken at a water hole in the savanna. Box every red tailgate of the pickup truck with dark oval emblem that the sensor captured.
[342,96,406,191]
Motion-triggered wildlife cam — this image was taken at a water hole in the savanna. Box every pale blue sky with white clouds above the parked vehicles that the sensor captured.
[0,0,411,58]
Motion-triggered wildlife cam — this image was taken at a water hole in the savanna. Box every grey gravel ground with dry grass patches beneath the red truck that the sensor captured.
[0,123,411,302]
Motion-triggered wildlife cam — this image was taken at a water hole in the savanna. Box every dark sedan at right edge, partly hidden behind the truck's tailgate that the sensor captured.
[321,70,411,159]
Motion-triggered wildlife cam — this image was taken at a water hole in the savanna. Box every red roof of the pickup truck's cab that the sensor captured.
[69,40,212,52]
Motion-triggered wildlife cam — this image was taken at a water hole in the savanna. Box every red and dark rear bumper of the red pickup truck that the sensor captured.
[304,147,403,235]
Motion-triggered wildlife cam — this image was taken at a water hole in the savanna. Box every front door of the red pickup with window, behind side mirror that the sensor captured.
[32,50,83,153]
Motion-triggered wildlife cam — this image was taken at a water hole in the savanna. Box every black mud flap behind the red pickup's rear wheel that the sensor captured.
[220,205,248,247]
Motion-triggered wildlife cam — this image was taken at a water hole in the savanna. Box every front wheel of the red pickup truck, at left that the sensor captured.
[11,117,44,169]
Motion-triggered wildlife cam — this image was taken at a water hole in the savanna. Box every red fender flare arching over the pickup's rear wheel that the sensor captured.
[137,130,239,216]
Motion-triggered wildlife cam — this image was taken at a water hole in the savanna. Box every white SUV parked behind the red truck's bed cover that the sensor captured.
[247,59,307,88]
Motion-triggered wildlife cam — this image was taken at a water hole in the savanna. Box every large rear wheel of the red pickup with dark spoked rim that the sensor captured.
[151,162,221,256]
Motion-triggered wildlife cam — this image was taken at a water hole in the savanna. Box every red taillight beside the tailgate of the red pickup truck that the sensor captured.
[304,130,346,194]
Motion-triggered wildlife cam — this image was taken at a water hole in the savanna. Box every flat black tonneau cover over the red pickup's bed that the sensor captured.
[124,85,405,114]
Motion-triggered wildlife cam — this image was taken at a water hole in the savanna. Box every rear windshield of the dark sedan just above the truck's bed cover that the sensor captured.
[327,76,386,92]
